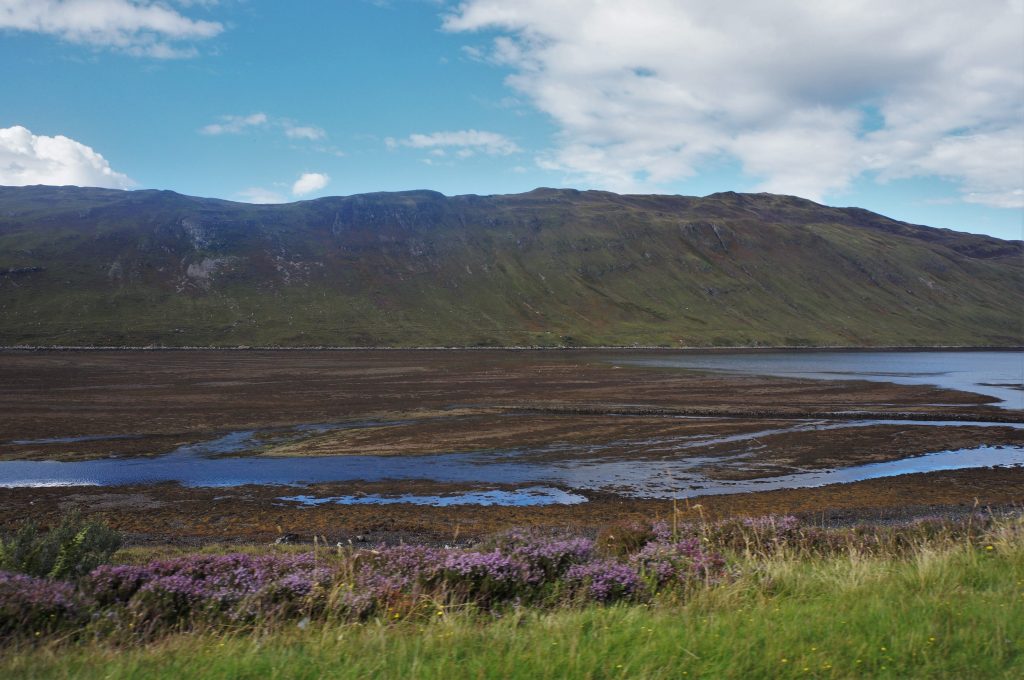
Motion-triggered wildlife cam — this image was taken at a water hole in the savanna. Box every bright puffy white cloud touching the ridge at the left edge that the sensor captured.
[0,125,134,188]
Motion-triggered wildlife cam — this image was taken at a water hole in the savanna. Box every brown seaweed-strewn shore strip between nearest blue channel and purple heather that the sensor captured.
[0,468,1024,547]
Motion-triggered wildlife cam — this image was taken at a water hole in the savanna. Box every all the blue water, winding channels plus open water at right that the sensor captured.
[0,352,1024,505]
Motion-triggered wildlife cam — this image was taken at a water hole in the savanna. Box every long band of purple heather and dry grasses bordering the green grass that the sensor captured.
[0,517,1022,640]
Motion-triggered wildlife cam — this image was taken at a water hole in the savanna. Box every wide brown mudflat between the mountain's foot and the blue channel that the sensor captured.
[0,350,1015,460]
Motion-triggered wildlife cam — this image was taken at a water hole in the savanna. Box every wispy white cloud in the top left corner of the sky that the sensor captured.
[0,0,224,58]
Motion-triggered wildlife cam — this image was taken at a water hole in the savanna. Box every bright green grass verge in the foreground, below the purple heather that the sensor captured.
[0,532,1024,679]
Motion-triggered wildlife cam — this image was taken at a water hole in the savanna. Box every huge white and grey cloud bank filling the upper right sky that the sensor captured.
[446,0,1024,207]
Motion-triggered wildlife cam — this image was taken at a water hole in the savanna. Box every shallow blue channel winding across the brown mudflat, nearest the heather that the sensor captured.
[0,413,1024,505]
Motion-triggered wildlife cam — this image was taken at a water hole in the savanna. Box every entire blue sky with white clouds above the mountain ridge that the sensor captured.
[0,0,1024,239]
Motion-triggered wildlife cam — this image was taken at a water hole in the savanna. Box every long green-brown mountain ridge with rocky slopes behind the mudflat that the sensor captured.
[0,186,1024,346]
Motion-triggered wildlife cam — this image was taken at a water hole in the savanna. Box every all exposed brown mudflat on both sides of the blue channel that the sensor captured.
[0,349,1024,541]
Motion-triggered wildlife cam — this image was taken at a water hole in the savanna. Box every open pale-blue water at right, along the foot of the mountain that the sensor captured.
[615,351,1024,409]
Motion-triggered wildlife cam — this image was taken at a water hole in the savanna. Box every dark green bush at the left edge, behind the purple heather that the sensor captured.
[0,511,123,579]
